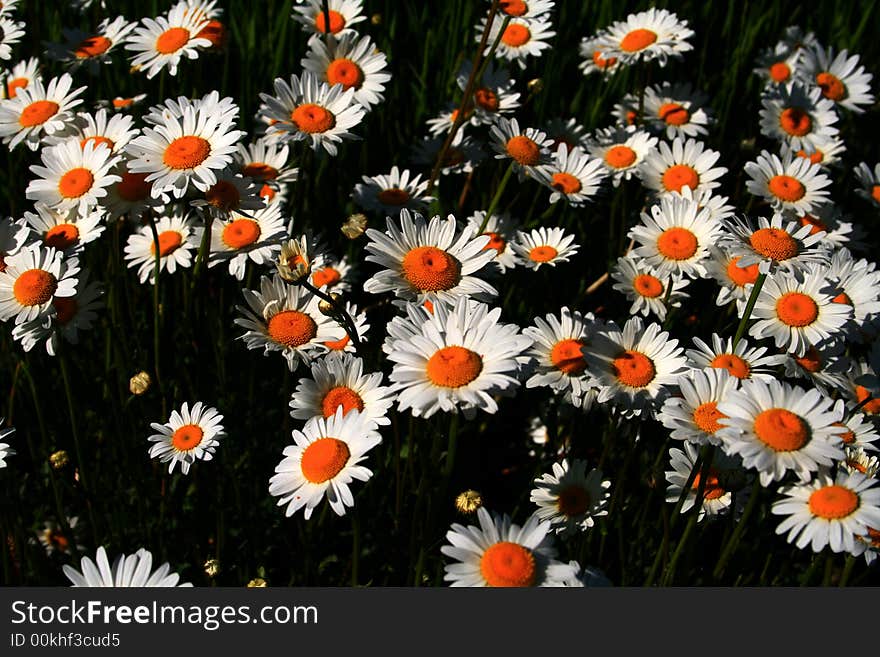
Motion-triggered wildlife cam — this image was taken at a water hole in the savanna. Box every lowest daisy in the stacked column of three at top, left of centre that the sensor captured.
[260,71,366,155]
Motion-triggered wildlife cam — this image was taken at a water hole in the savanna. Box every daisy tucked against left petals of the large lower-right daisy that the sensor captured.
[657,367,739,446]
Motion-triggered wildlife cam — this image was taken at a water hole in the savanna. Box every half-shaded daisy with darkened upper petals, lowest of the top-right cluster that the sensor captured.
[760,82,837,150]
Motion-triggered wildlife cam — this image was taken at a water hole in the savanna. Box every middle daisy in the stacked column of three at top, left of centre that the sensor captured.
[302,32,391,109]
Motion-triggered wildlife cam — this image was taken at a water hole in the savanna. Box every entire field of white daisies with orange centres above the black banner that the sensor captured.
[0,0,880,587]
